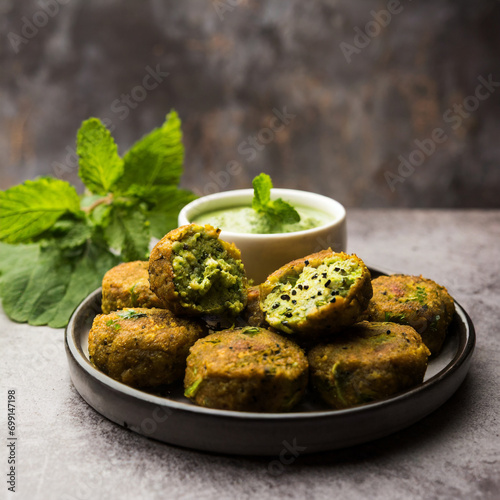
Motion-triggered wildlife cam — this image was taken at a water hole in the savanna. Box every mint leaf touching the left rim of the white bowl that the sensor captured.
[147,186,196,238]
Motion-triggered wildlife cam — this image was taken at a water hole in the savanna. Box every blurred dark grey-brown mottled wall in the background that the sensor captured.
[0,0,500,207]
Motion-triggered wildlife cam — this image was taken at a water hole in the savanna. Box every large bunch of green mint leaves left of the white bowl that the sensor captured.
[0,111,195,327]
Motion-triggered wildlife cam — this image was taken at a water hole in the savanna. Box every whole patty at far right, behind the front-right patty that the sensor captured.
[363,274,455,355]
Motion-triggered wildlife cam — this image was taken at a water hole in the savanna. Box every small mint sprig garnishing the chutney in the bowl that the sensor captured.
[252,173,300,227]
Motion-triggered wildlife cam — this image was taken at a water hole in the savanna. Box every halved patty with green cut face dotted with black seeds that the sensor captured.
[260,249,372,336]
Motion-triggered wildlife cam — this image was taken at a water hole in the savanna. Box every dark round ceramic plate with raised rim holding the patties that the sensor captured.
[66,271,475,456]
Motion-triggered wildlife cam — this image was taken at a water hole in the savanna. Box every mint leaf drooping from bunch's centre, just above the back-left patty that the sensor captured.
[104,205,151,261]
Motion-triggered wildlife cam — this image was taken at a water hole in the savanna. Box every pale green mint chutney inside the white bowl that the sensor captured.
[191,204,332,234]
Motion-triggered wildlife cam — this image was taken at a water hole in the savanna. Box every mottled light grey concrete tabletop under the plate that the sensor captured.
[0,210,500,500]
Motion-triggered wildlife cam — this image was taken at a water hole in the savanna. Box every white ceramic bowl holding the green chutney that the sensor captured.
[179,188,347,284]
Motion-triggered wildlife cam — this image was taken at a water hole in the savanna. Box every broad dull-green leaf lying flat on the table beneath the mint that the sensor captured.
[0,244,119,328]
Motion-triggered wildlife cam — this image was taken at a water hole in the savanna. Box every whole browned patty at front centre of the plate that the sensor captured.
[184,327,308,412]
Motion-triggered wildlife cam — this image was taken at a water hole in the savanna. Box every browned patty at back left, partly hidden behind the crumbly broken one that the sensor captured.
[101,260,163,314]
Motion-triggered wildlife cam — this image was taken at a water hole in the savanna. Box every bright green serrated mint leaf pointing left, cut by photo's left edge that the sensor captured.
[0,177,80,243]
